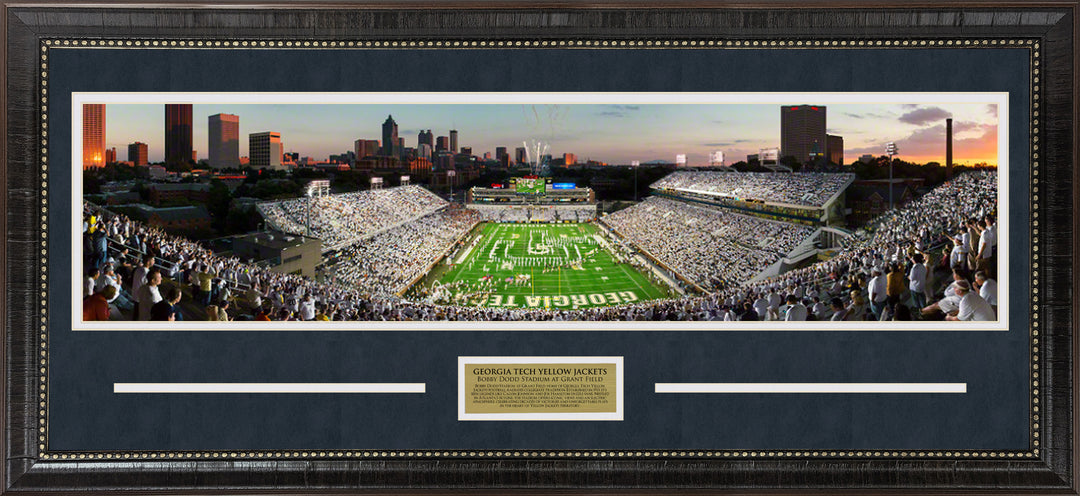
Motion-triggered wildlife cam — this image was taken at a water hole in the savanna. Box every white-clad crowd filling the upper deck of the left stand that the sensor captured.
[258,186,447,250]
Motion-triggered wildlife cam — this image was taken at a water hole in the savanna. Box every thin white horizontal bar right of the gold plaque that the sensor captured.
[656,383,968,393]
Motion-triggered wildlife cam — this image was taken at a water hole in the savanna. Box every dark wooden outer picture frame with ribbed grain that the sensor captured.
[0,0,1080,494]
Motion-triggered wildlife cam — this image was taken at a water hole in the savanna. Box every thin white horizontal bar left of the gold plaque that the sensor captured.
[112,383,428,393]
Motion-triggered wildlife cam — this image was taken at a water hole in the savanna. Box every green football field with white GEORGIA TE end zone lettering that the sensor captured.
[407,223,671,309]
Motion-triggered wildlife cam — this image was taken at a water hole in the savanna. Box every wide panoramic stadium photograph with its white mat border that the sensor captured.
[71,94,1007,329]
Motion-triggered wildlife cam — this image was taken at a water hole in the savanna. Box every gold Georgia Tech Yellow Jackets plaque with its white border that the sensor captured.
[458,357,623,420]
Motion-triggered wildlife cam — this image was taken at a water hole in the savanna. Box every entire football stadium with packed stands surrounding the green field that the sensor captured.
[83,167,998,321]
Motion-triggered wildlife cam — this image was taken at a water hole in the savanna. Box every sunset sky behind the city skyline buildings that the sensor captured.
[106,102,998,165]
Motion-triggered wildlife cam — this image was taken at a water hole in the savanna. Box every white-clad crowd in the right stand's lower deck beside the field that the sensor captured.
[604,197,813,290]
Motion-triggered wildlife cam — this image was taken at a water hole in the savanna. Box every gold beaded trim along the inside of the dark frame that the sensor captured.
[37,38,1041,461]
